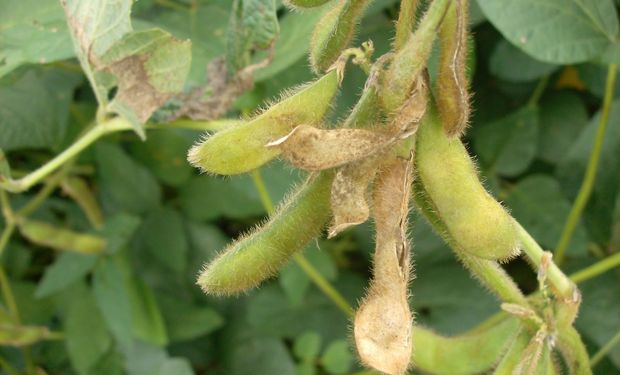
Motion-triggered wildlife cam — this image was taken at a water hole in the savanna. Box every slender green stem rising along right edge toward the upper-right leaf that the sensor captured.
[555,64,618,265]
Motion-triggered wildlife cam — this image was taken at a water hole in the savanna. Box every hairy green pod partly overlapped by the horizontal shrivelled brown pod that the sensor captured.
[188,70,339,175]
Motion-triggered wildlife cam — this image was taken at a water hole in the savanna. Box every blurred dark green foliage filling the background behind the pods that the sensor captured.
[0,0,620,375]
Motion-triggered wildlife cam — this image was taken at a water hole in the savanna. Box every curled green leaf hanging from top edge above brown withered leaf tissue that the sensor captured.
[226,0,280,72]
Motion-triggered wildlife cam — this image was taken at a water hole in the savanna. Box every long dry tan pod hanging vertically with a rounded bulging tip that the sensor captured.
[354,158,412,374]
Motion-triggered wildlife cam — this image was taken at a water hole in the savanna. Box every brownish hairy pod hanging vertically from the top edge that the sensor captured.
[437,0,470,137]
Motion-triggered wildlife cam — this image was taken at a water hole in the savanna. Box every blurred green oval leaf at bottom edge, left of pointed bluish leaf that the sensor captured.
[64,286,112,374]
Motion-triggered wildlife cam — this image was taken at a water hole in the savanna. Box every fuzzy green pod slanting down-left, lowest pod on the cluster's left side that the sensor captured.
[198,172,333,295]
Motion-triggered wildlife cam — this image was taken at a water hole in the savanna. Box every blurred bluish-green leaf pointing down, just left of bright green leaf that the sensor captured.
[93,259,132,351]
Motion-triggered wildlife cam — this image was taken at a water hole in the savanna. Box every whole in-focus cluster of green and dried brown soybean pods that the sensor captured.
[189,0,590,374]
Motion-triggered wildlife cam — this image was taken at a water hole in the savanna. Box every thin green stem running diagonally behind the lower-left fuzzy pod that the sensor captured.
[252,169,354,317]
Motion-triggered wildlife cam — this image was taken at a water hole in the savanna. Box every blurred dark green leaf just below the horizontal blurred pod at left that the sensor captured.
[35,253,98,298]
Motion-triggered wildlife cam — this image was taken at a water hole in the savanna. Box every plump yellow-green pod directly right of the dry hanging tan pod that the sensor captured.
[416,106,520,260]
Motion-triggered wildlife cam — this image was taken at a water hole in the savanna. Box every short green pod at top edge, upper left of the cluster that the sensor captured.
[310,0,368,72]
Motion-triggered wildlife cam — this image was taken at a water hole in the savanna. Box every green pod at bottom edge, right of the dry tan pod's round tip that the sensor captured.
[413,317,527,375]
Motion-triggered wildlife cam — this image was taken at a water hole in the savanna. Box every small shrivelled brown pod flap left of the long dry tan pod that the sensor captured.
[328,153,384,238]
